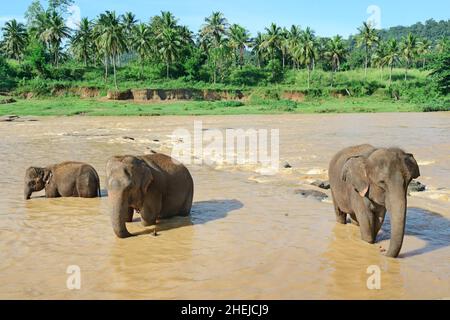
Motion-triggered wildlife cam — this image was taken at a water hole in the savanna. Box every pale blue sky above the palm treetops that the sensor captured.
[0,0,450,36]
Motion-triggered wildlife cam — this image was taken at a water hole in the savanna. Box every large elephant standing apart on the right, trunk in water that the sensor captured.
[328,144,420,258]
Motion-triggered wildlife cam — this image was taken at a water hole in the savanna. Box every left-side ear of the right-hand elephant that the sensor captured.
[342,157,369,197]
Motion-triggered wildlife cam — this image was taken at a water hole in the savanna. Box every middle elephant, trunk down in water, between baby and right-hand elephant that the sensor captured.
[106,153,194,238]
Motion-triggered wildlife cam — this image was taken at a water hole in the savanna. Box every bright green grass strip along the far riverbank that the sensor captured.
[0,97,422,116]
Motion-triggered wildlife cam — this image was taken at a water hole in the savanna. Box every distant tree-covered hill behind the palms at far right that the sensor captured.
[380,19,450,43]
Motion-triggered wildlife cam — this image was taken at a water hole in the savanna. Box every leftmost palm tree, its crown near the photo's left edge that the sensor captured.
[2,19,28,60]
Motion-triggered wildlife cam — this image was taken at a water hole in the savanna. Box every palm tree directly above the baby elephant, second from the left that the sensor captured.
[41,11,70,67]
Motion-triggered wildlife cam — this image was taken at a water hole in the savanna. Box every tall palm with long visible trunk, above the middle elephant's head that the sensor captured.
[97,11,126,89]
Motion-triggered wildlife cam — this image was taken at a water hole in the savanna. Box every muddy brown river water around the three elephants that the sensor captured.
[0,113,450,299]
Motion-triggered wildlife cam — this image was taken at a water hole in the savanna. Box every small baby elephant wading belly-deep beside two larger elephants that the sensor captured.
[24,161,100,200]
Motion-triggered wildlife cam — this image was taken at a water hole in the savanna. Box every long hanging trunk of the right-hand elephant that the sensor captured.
[386,190,406,258]
